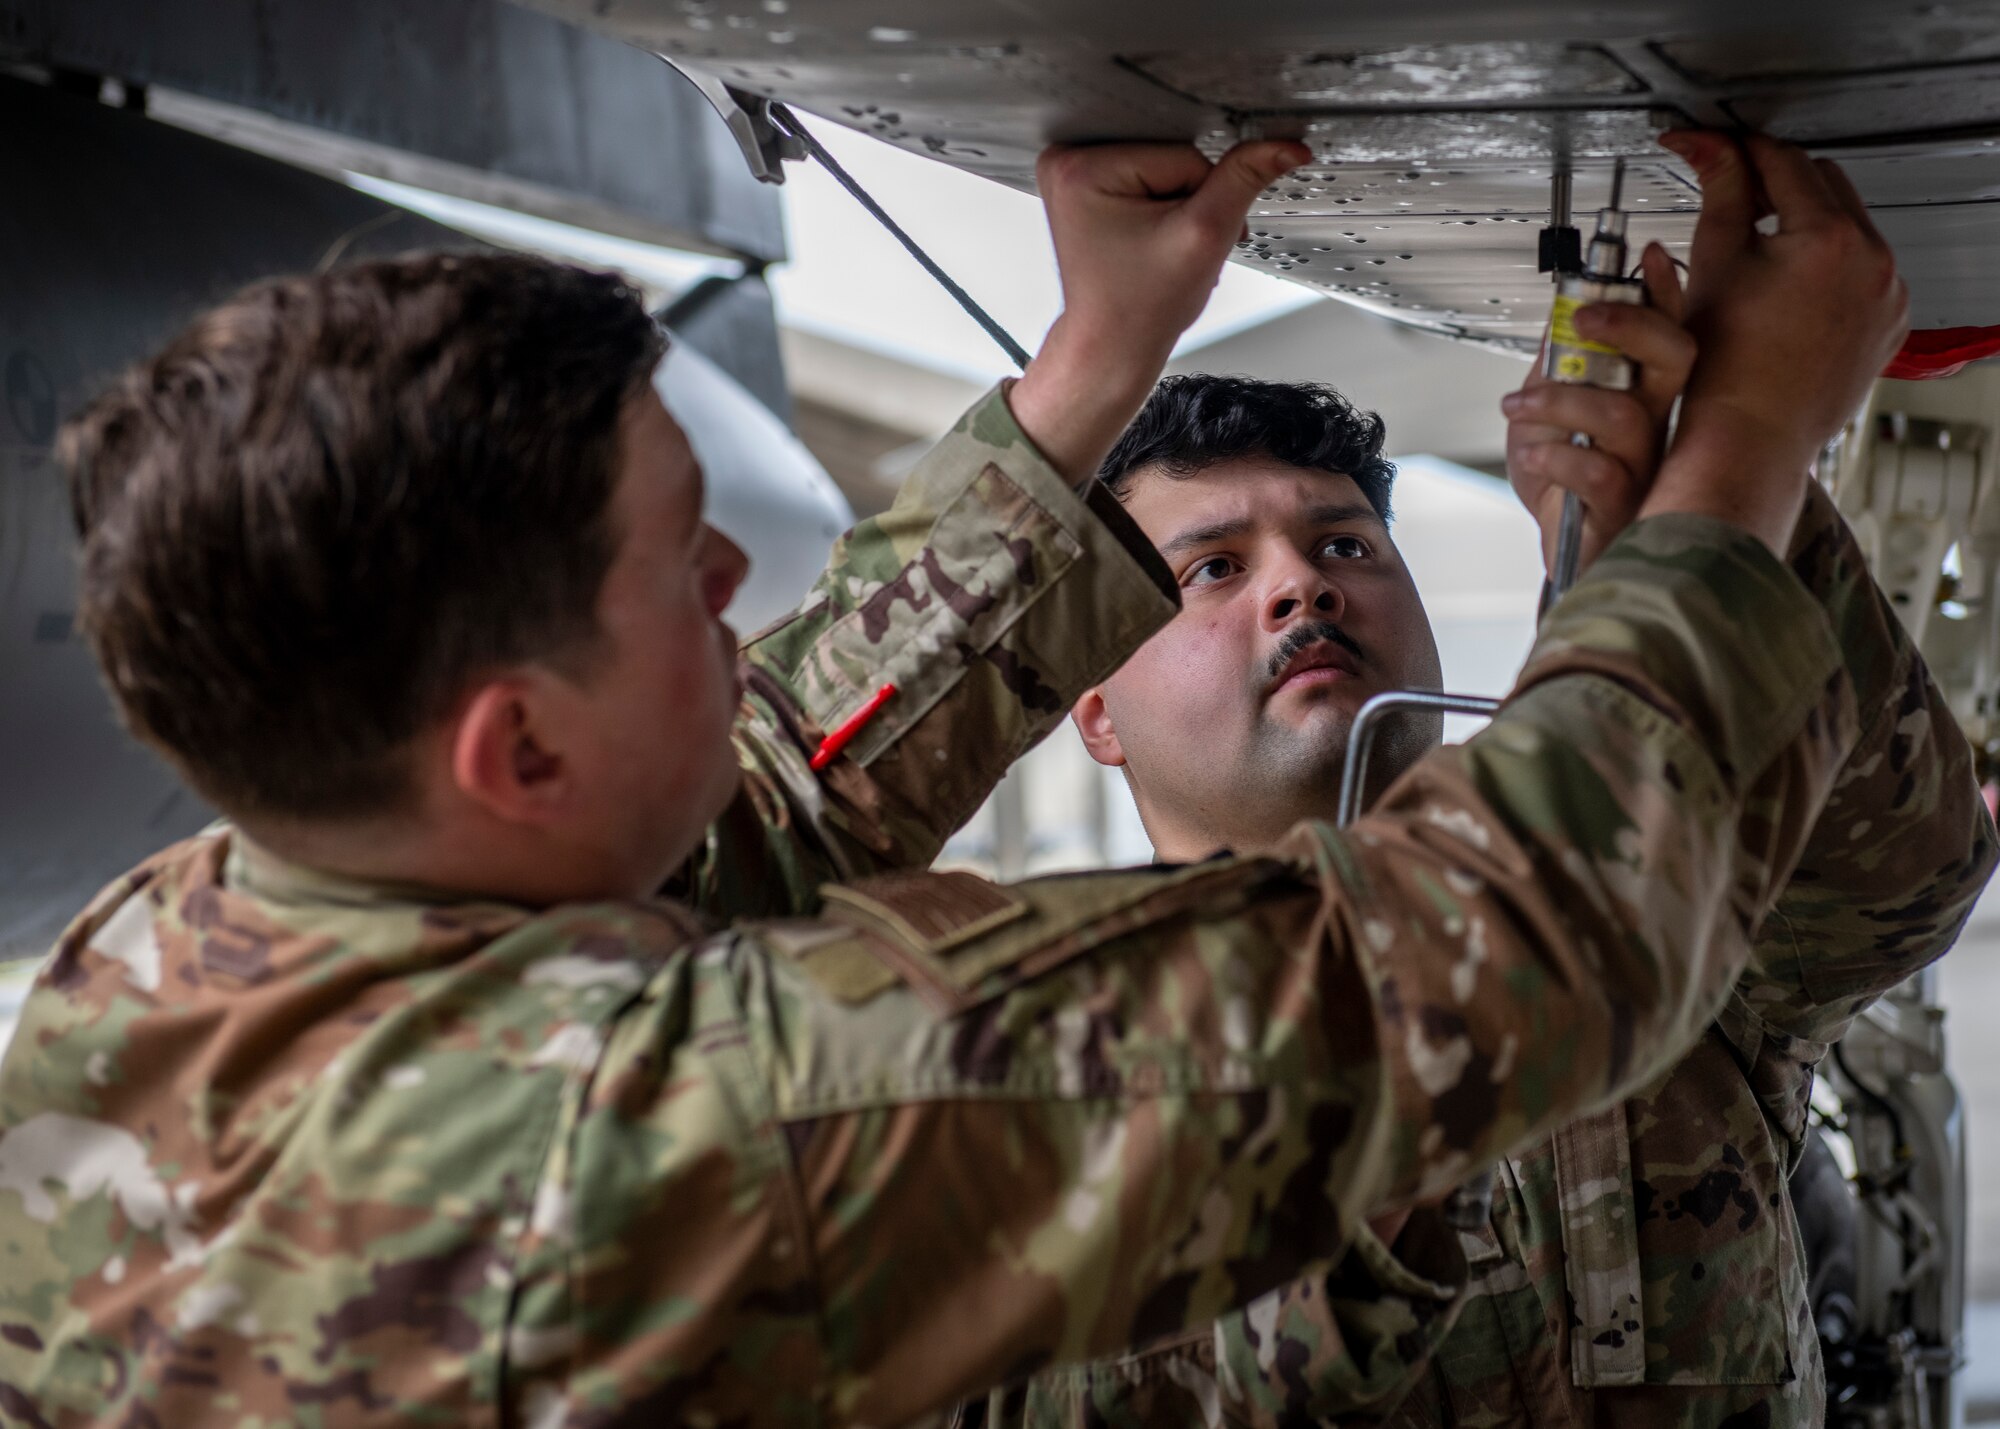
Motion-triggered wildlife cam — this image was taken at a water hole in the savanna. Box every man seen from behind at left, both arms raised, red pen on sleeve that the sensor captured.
[0,142,1904,1429]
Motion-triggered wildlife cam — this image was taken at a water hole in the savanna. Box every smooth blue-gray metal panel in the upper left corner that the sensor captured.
[0,0,784,264]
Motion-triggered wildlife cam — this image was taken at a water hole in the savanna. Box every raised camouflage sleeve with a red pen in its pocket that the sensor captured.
[668,378,1178,917]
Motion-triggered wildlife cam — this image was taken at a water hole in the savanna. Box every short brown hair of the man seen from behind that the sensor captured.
[56,254,664,819]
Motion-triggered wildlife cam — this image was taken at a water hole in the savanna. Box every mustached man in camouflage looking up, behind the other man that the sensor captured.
[964,134,1996,1429]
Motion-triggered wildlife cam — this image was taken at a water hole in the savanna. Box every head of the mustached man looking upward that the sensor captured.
[1076,364,1440,861]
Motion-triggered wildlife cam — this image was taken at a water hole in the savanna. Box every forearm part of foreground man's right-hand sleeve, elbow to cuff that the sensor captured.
[1352,518,1854,1195]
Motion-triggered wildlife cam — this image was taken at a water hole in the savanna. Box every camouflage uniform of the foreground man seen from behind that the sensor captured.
[0,384,1854,1429]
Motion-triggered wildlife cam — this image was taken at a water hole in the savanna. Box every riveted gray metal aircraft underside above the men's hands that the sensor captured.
[534,0,2000,348]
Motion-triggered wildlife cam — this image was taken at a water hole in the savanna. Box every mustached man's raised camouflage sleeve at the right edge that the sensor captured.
[1724,486,1996,1059]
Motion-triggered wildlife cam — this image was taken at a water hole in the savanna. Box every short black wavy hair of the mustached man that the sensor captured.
[1098,372,1396,520]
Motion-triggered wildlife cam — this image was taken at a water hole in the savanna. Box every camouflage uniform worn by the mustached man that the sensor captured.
[964,488,1994,1429]
